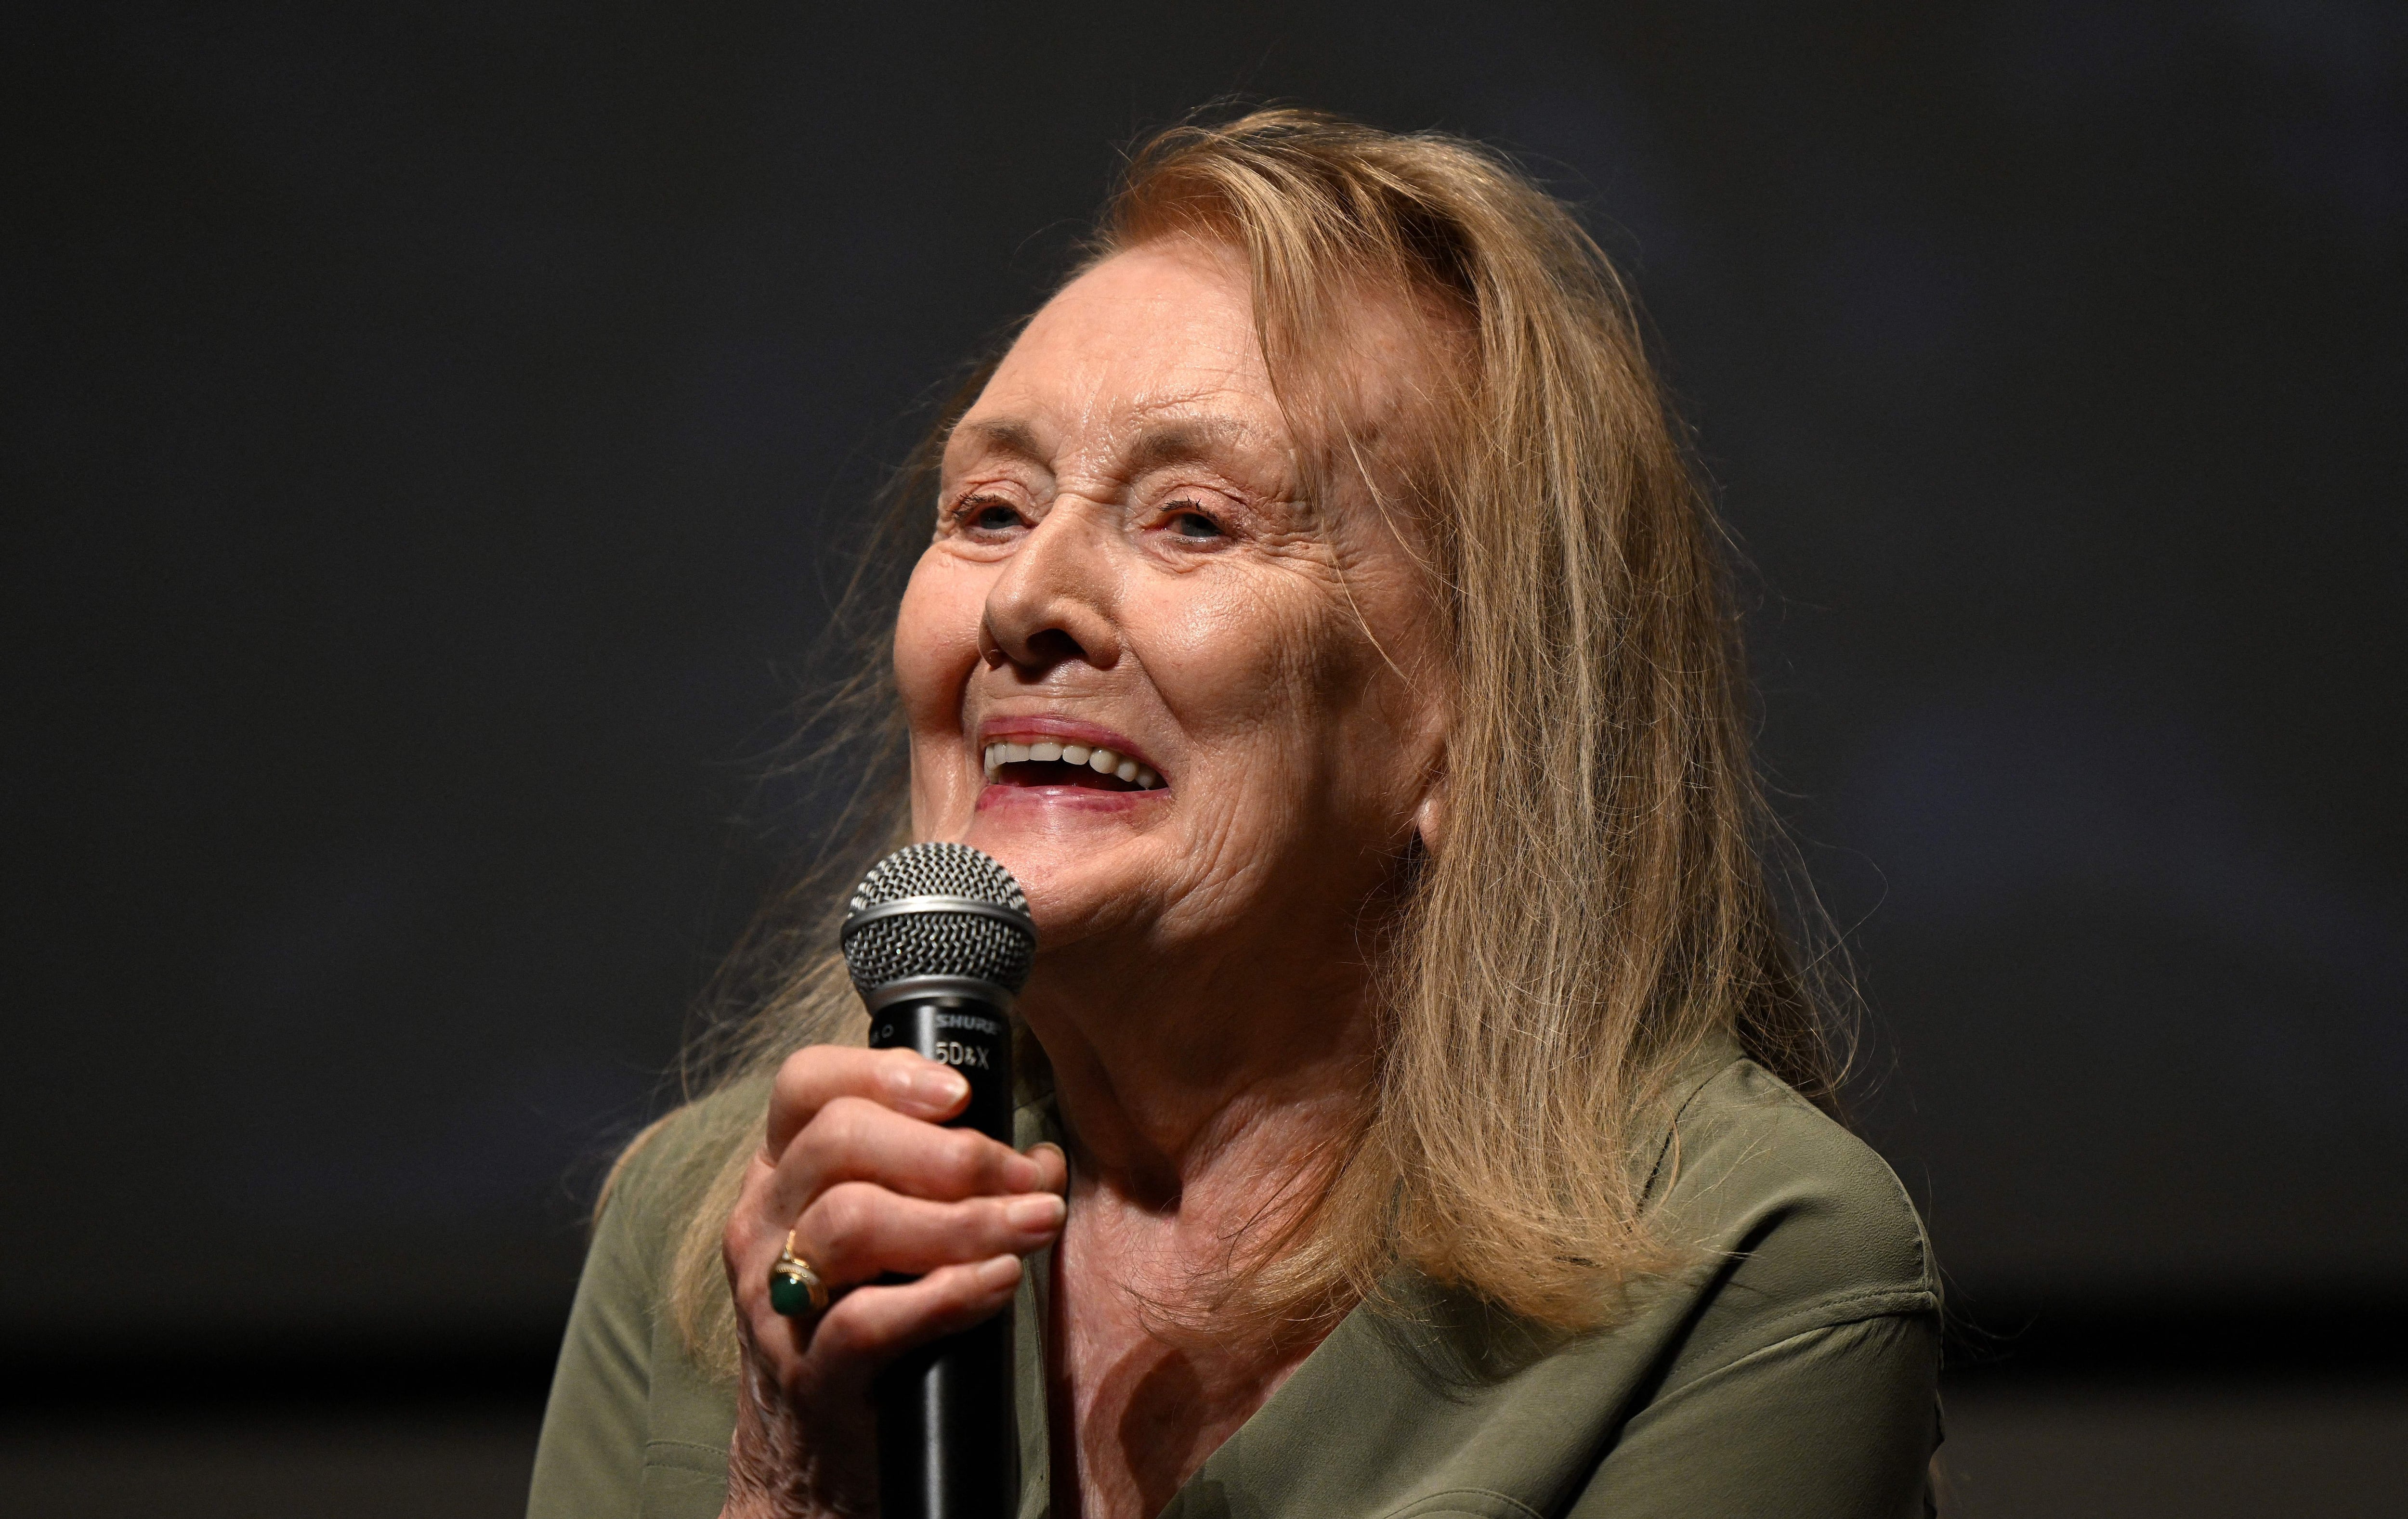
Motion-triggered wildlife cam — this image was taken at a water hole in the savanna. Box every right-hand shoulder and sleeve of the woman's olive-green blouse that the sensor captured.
[1137,1050,1938,1519]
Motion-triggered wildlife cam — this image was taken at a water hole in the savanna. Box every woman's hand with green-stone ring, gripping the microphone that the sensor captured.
[722,1045,1069,1519]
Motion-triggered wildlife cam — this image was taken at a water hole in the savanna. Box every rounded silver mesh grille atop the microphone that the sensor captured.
[843,843,1038,997]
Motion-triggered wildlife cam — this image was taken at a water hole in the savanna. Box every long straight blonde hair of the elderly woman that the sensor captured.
[636,111,1840,1370]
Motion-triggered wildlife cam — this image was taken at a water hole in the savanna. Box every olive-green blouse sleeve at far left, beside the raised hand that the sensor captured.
[527,1141,657,1519]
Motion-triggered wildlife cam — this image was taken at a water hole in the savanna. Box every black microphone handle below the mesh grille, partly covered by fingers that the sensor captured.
[869,997,1021,1519]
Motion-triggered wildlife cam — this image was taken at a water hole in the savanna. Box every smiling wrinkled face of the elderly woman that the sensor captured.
[896,243,1445,968]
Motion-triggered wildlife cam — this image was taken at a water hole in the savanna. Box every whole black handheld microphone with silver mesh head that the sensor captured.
[838,843,1038,1519]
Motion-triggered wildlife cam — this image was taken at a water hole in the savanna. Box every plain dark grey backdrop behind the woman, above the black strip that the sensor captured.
[0,0,2408,1377]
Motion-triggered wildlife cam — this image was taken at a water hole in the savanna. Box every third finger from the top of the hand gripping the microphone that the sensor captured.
[795,1182,1064,1288]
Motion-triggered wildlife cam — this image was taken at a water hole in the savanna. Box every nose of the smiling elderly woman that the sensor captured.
[978,496,1120,676]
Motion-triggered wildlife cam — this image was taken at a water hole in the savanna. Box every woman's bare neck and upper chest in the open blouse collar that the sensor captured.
[1021,915,1375,1514]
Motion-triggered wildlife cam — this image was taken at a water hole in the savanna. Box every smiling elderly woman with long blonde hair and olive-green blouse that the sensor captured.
[532,111,1938,1519]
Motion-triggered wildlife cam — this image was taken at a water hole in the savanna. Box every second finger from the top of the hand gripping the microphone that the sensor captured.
[761,1098,1045,1233]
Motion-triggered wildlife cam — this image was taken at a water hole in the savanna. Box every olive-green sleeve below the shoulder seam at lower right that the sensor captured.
[1570,1312,1938,1519]
